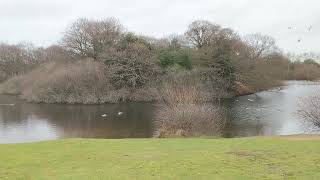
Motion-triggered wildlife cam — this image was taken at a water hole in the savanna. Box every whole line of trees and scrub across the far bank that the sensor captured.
[0,18,320,104]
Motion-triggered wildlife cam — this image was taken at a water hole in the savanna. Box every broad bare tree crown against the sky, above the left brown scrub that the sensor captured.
[62,18,123,60]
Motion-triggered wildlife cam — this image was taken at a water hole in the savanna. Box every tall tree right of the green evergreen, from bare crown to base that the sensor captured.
[185,21,241,97]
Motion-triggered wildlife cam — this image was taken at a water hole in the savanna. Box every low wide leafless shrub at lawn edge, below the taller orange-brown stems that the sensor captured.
[156,104,225,137]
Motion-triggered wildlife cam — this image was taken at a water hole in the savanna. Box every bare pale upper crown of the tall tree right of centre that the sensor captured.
[185,20,221,48]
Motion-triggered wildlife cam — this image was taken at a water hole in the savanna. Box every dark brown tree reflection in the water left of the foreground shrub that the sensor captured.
[0,103,153,138]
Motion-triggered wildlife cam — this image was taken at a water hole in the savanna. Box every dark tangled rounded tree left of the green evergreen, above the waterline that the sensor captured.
[102,33,160,89]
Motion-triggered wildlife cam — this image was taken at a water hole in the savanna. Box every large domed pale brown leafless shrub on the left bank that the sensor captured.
[22,61,110,104]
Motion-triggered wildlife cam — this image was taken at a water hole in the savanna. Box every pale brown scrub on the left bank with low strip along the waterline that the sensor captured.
[0,60,158,104]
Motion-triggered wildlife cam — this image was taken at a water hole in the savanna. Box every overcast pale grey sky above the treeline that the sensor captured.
[0,0,320,53]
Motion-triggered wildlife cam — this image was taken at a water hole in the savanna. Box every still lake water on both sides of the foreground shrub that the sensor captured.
[0,81,320,143]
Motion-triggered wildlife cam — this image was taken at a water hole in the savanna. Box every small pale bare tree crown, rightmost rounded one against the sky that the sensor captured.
[244,33,277,60]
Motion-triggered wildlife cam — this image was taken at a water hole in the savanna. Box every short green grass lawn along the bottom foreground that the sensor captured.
[0,137,320,180]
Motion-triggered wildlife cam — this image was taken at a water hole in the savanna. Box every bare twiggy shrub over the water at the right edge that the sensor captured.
[298,93,320,127]
